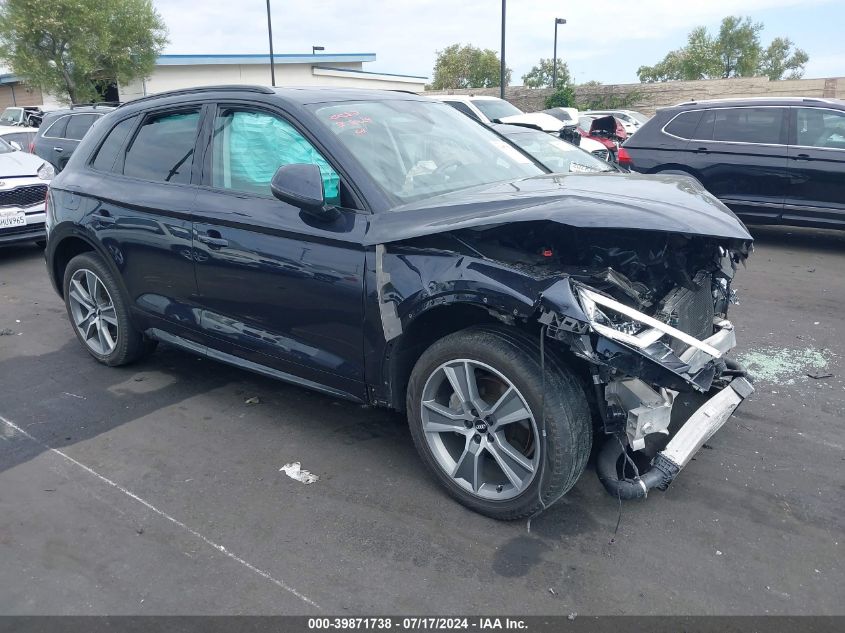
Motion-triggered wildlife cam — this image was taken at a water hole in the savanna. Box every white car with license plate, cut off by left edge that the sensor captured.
[0,139,55,244]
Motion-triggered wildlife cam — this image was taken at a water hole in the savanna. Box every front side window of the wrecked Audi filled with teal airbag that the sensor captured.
[211,108,340,205]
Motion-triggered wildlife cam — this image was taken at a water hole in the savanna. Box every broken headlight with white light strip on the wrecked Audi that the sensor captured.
[578,286,722,358]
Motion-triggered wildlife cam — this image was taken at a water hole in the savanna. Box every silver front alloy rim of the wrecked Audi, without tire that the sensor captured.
[420,359,540,501]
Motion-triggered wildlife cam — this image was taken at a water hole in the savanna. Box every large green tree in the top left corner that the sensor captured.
[0,0,167,103]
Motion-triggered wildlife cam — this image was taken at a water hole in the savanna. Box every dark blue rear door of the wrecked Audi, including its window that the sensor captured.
[80,106,201,341]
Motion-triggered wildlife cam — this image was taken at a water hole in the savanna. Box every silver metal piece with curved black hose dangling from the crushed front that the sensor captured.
[596,376,754,499]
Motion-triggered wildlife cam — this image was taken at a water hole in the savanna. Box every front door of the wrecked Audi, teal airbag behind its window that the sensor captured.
[193,103,368,399]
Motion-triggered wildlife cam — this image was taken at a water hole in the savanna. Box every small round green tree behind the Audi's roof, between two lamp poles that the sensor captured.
[430,44,511,90]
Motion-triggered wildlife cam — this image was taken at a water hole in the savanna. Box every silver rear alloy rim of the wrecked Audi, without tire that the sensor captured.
[68,268,118,356]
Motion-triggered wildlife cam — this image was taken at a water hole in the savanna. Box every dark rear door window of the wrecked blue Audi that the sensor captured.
[123,110,200,184]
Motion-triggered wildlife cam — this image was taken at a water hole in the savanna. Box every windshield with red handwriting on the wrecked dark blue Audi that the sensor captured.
[311,100,544,204]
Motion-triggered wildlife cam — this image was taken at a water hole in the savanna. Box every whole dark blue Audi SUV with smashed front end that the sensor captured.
[42,86,753,519]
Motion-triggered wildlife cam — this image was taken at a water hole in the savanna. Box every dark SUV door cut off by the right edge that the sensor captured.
[783,107,845,225]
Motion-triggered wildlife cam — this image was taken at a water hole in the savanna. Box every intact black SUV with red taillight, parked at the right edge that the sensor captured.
[623,98,845,228]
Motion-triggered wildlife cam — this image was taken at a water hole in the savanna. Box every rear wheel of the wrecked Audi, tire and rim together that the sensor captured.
[63,252,153,367]
